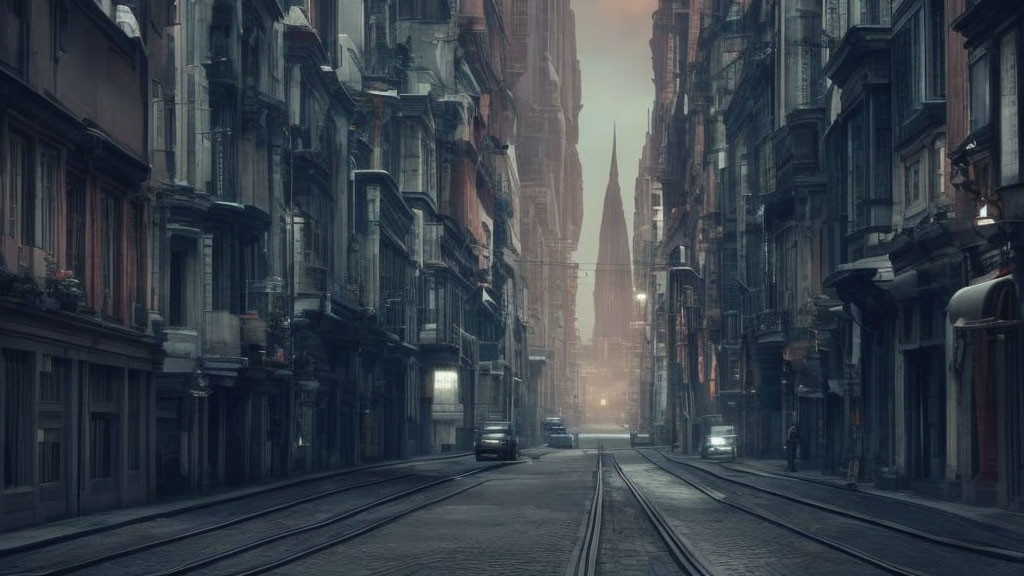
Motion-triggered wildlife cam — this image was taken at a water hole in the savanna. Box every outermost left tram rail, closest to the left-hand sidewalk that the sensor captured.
[0,452,473,559]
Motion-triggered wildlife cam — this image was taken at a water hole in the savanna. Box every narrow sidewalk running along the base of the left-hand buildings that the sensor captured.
[0,452,472,556]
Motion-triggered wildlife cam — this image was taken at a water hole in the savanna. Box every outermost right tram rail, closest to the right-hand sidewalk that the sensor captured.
[648,451,1024,564]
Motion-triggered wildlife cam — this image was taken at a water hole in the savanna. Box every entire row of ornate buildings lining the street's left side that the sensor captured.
[0,0,569,529]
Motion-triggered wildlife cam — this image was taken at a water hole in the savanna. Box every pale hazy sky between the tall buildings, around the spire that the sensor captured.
[572,0,657,341]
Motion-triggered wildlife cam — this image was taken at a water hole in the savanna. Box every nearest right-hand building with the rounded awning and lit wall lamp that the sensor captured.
[943,0,1024,509]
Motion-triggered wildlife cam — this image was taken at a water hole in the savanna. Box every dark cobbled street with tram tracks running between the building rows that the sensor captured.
[0,434,1024,575]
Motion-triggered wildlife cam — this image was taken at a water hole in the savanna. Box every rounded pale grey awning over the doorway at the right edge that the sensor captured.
[949,276,1021,330]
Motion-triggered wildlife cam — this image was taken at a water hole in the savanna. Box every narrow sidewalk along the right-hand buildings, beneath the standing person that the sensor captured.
[732,458,1024,535]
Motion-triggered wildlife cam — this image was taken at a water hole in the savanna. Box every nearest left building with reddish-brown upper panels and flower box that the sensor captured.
[0,0,167,528]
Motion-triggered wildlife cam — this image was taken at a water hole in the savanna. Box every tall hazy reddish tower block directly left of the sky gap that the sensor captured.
[508,0,583,435]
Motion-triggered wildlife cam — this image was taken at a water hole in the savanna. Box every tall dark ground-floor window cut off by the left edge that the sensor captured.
[2,349,35,488]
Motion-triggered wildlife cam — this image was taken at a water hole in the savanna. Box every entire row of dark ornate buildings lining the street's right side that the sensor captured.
[637,0,1022,506]
